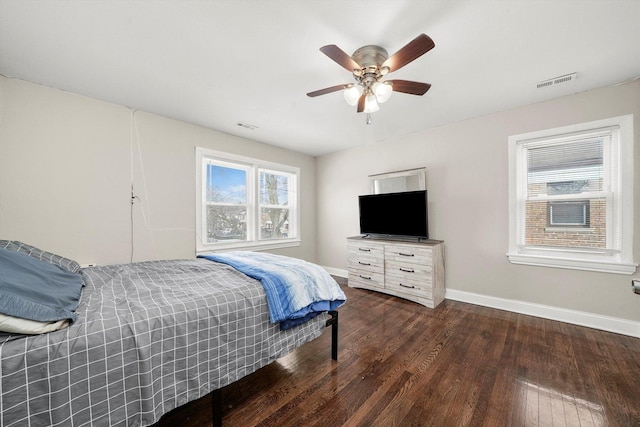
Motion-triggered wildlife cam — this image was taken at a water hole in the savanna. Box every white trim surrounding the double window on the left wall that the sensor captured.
[195,147,301,255]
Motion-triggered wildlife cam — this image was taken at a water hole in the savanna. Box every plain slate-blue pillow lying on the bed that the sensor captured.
[0,248,83,322]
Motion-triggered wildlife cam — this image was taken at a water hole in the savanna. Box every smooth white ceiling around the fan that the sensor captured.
[0,0,640,156]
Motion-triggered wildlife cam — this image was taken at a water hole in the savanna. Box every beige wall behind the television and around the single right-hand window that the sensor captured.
[316,81,640,321]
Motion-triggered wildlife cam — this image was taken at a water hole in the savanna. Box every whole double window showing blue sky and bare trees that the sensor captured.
[196,147,300,252]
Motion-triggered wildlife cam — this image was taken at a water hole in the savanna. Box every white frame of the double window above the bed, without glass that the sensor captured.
[195,147,301,254]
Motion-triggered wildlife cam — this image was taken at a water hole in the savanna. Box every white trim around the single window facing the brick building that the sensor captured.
[507,114,638,274]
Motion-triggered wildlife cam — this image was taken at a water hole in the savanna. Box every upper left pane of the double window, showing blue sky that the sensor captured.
[206,164,247,205]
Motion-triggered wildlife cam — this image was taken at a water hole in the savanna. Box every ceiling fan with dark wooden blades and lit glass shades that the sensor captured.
[307,34,435,124]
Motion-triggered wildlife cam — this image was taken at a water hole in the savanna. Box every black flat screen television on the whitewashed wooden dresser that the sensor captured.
[358,190,429,239]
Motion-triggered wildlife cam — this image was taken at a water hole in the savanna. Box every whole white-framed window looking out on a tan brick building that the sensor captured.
[507,115,637,274]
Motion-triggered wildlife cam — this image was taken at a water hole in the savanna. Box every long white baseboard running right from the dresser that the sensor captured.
[445,289,640,338]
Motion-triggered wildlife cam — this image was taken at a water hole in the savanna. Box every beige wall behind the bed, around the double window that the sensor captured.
[0,76,316,264]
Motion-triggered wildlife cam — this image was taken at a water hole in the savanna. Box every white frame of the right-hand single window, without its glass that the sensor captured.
[507,115,638,274]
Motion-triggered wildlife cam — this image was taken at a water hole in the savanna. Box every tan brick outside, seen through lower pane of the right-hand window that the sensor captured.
[525,198,606,249]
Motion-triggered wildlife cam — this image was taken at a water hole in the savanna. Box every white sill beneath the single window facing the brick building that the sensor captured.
[507,253,638,274]
